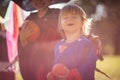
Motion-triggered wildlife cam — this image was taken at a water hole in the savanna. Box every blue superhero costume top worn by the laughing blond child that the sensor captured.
[54,36,97,80]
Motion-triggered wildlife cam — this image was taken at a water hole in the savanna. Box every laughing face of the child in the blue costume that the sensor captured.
[61,13,83,32]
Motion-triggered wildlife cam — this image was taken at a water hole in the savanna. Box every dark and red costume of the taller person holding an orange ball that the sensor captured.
[18,9,61,80]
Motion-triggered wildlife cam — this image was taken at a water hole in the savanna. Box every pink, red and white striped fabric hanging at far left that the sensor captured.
[4,1,28,63]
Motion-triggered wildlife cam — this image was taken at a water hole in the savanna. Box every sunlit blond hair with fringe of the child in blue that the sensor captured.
[58,4,91,38]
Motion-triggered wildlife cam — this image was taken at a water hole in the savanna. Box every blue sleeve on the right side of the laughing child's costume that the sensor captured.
[78,44,97,80]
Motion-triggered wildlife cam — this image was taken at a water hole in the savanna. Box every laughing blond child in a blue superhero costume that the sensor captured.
[48,4,98,80]
